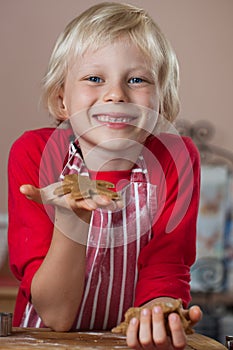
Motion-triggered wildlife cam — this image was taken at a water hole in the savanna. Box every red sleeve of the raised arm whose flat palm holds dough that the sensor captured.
[8,128,71,326]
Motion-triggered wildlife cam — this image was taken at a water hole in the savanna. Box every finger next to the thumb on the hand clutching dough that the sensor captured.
[168,313,186,349]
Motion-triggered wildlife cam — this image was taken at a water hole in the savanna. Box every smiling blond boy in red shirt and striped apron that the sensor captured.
[9,3,201,349]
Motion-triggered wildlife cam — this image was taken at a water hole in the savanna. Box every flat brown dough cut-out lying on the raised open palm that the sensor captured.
[53,174,121,200]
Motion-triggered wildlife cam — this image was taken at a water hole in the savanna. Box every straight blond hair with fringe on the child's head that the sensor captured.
[43,2,179,121]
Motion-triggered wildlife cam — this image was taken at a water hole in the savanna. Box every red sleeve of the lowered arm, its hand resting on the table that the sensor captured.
[135,136,200,307]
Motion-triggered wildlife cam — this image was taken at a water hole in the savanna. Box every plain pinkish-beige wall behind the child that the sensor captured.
[0,0,233,212]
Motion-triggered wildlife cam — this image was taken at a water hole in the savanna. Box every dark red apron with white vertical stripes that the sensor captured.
[20,144,157,330]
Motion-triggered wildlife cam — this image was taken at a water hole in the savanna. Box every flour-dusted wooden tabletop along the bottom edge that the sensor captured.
[0,328,226,350]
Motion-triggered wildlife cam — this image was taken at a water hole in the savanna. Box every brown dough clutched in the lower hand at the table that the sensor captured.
[112,299,194,335]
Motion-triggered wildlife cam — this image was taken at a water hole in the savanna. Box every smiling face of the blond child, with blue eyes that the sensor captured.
[60,38,158,153]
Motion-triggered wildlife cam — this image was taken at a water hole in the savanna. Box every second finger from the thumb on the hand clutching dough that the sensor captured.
[152,306,169,349]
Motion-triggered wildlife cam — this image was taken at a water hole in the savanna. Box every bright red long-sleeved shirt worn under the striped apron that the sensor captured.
[9,128,200,326]
